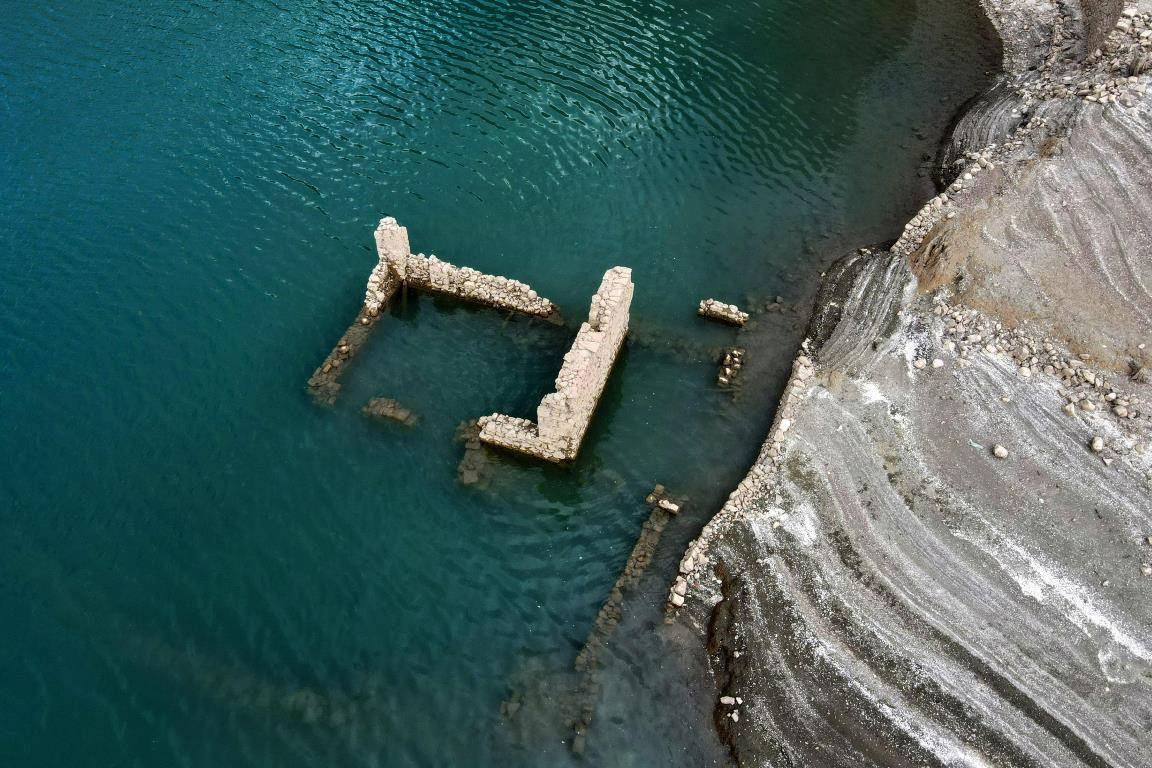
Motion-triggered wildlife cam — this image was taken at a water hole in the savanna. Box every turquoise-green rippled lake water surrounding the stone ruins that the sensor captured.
[0,0,999,768]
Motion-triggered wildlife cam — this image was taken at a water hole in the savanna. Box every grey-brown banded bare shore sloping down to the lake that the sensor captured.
[669,0,1152,768]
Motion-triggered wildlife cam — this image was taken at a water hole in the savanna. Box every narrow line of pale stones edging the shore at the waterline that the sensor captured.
[666,354,816,622]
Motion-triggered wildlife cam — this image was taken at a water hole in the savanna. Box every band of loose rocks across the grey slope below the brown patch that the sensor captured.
[930,294,1152,472]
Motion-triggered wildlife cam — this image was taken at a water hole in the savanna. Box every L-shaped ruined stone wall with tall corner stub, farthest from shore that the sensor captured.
[308,216,556,404]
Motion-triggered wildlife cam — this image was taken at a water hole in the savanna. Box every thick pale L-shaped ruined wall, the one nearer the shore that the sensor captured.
[479,267,634,462]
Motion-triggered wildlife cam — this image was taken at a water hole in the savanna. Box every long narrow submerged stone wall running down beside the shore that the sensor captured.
[571,485,682,754]
